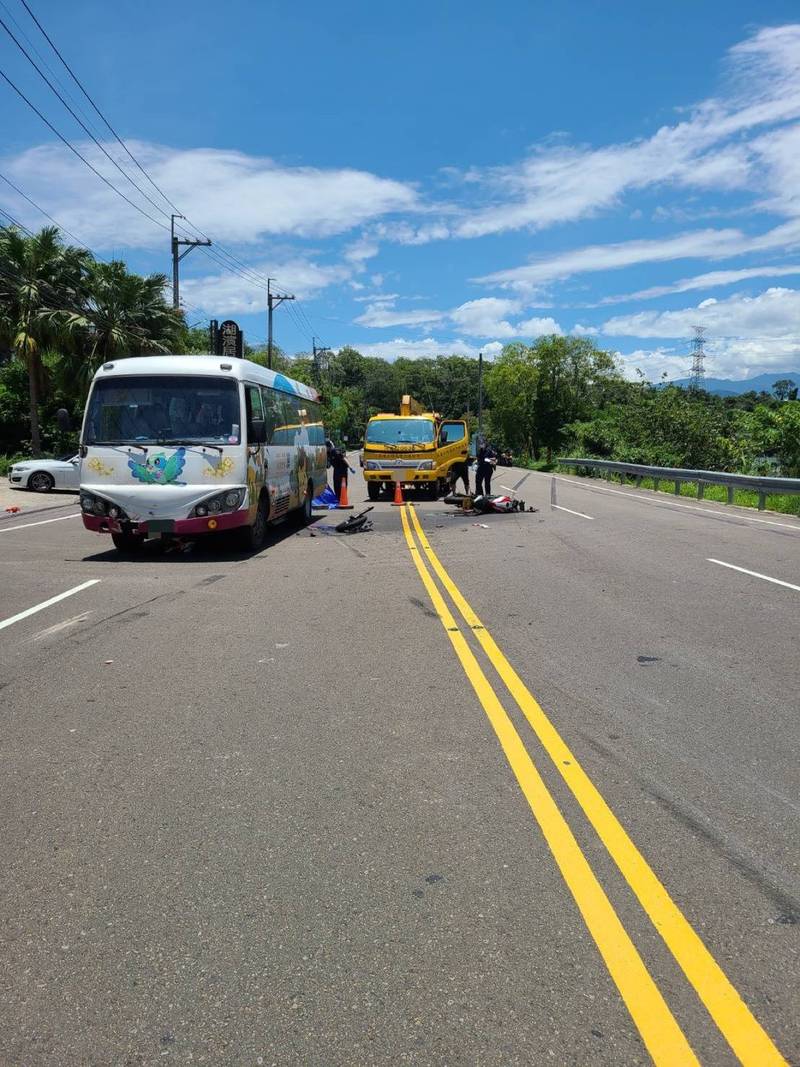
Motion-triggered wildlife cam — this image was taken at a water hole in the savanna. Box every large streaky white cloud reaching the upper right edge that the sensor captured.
[453,26,800,237]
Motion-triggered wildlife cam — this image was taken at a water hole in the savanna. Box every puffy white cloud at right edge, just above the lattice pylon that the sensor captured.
[603,288,800,341]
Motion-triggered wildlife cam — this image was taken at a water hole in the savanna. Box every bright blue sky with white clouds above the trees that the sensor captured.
[0,0,800,379]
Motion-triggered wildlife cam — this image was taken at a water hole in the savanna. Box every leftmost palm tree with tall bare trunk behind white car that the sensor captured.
[0,226,92,456]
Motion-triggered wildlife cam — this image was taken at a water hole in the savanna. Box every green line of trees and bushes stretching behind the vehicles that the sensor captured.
[0,227,800,477]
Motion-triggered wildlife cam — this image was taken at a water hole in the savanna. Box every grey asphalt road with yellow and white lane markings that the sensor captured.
[0,469,800,1067]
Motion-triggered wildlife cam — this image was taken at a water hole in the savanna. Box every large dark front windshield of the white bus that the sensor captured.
[83,375,241,445]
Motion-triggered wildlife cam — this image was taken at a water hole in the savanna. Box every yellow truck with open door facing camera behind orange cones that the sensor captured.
[362,396,469,500]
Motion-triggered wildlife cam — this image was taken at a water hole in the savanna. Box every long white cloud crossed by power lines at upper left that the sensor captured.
[3,141,418,248]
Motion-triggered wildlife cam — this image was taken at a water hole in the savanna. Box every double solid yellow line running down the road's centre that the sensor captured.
[401,506,787,1067]
